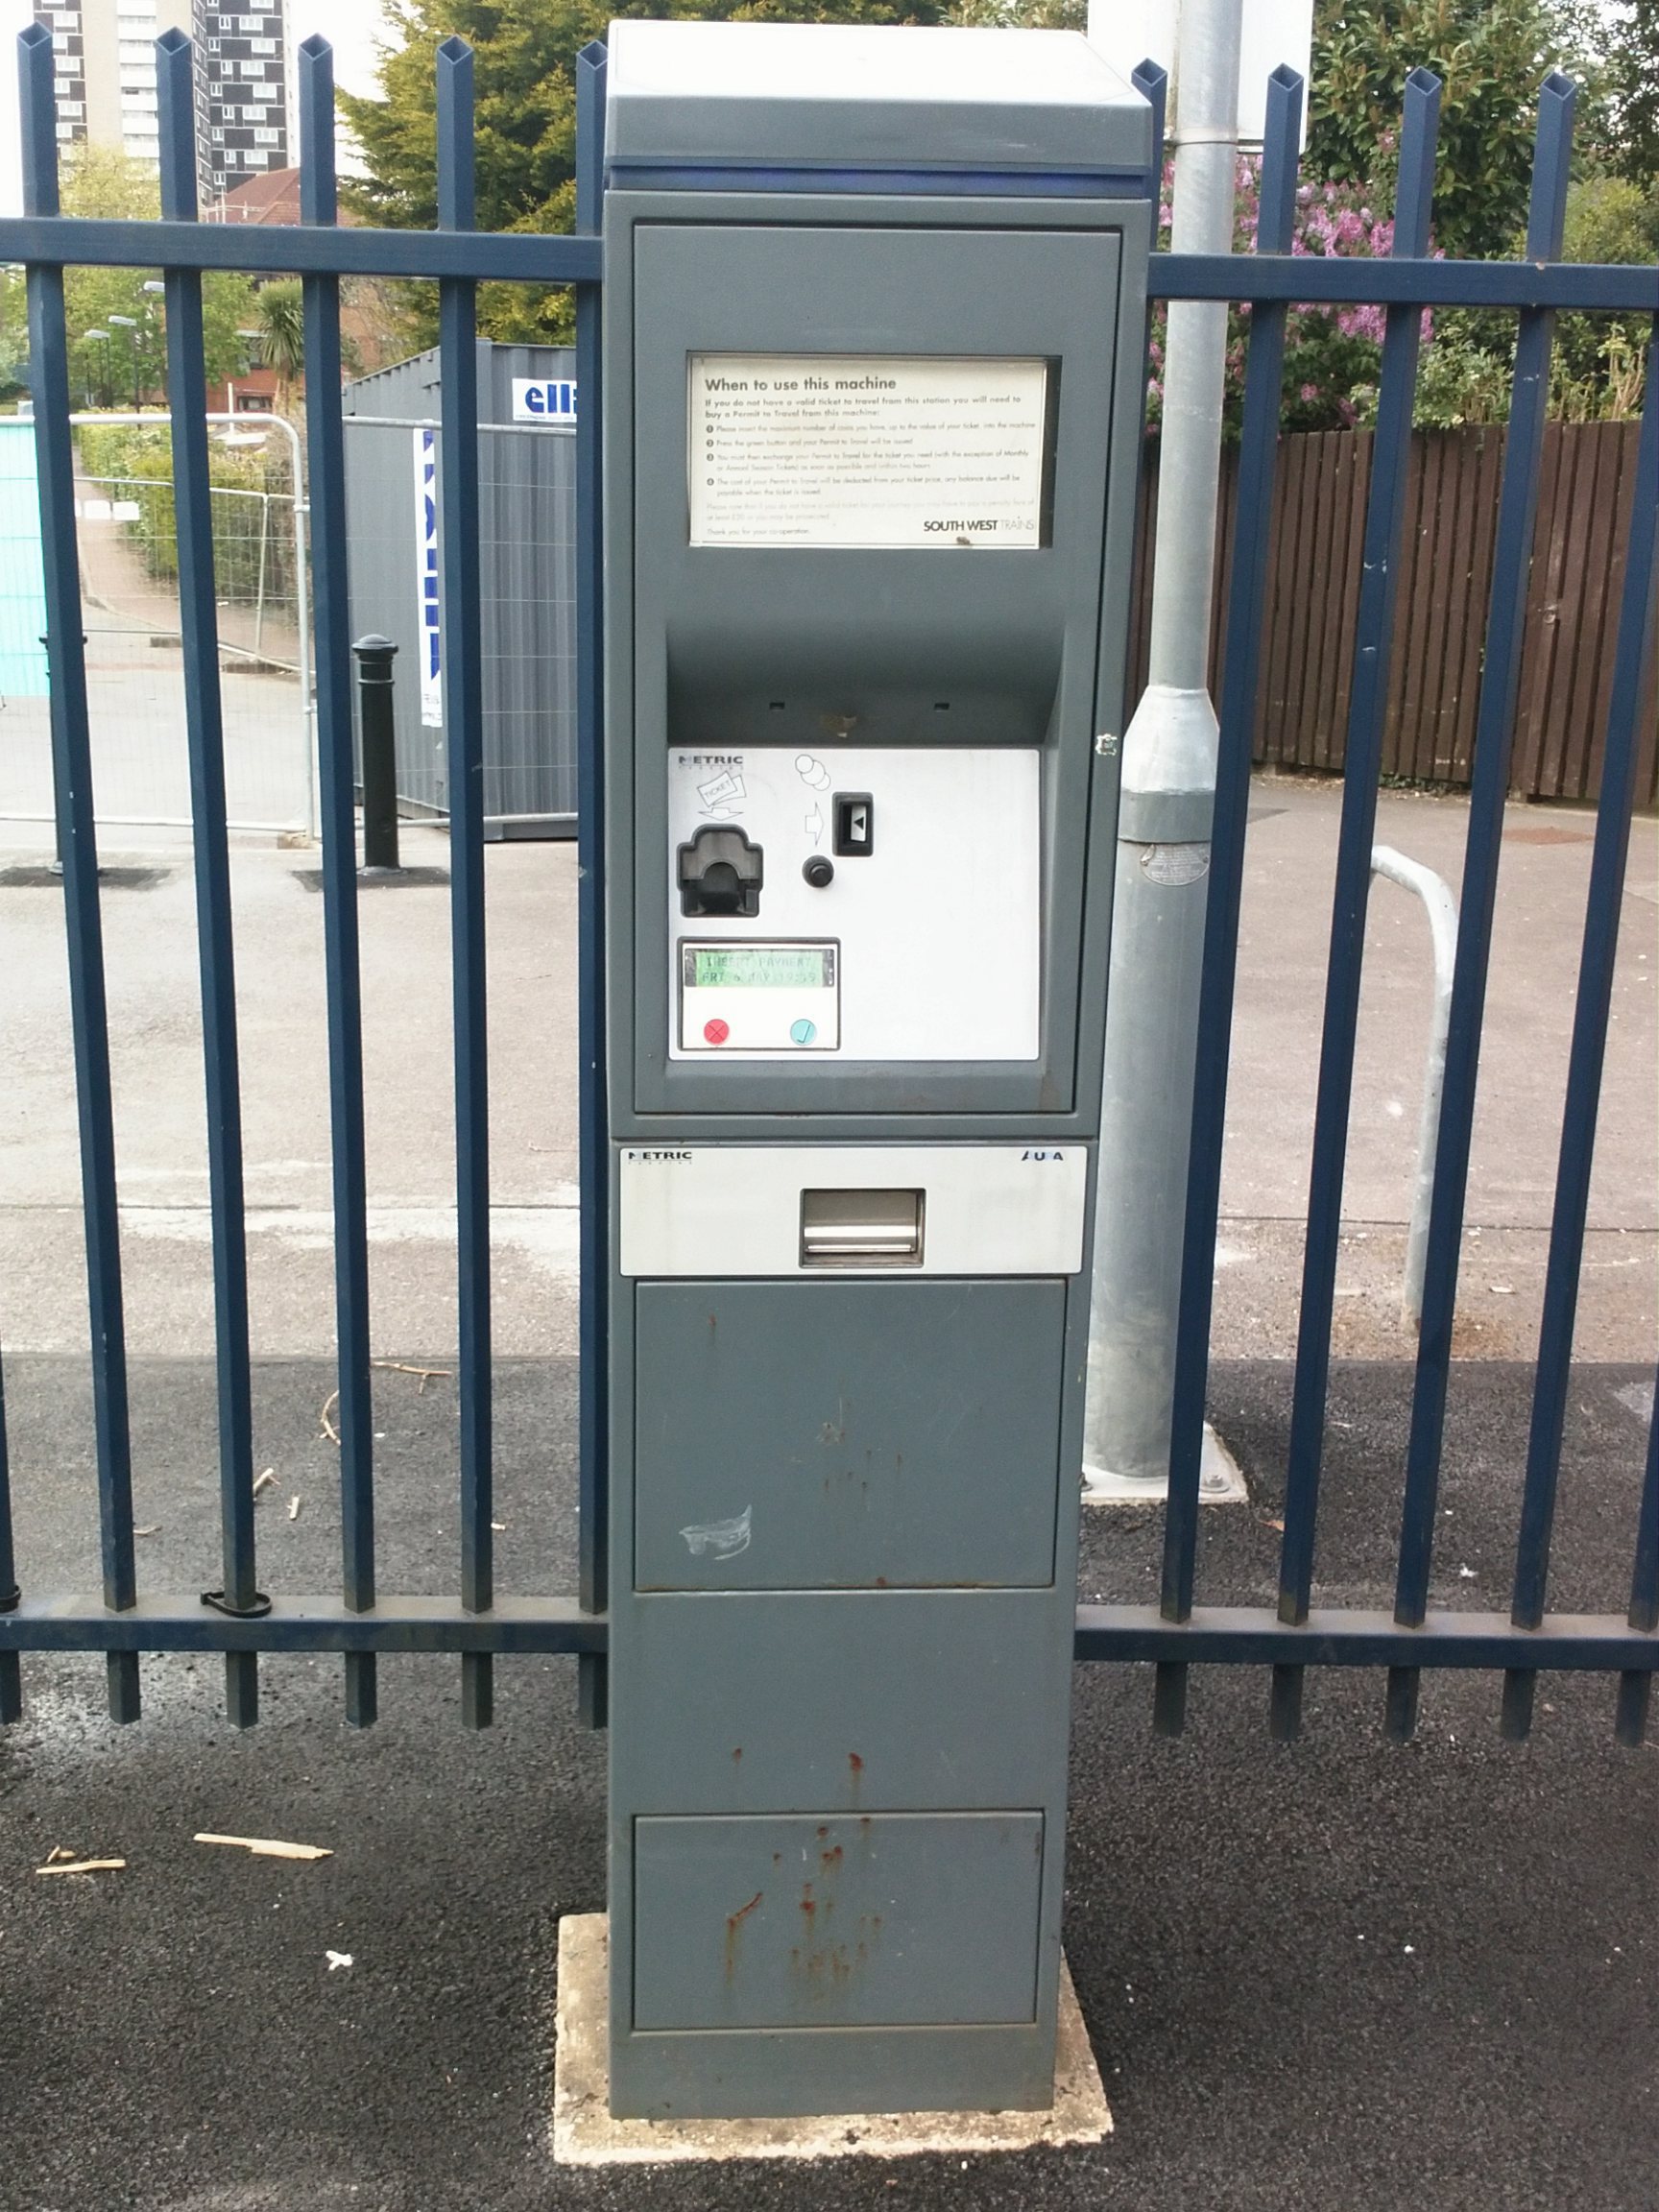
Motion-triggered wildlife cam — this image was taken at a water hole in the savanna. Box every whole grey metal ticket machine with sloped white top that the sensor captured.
[604,22,1152,2115]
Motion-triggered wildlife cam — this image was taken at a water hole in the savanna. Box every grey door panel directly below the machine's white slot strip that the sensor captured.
[635,1279,1067,1591]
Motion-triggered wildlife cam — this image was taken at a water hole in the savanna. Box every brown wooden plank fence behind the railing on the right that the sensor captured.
[1130,422,1659,805]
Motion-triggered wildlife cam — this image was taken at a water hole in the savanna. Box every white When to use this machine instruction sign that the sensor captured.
[685,354,1048,548]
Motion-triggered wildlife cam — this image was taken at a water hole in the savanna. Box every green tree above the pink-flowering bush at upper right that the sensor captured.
[1305,0,1601,256]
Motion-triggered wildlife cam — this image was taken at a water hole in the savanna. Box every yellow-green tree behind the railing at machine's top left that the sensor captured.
[339,0,945,345]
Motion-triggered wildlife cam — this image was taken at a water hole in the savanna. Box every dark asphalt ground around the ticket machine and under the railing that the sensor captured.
[0,1356,1659,2212]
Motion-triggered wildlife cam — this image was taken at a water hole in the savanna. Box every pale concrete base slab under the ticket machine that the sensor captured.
[553,1913,1113,2166]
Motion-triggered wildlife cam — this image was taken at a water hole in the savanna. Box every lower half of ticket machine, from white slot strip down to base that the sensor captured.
[611,1176,1106,2117]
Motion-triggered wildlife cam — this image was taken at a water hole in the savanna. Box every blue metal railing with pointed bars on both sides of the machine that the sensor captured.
[0,27,1659,1743]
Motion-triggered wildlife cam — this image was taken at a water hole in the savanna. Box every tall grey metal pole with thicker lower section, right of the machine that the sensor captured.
[1084,0,1243,1493]
